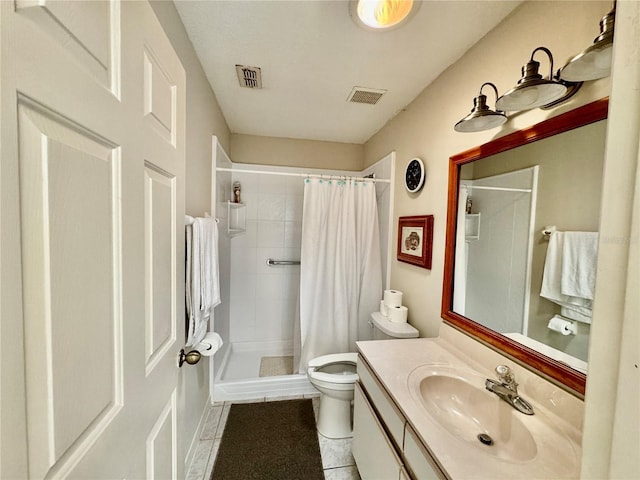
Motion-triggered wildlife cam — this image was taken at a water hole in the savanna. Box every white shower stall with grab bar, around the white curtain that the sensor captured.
[210,138,394,401]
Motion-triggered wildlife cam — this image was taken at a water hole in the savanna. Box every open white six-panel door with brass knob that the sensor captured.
[0,0,185,479]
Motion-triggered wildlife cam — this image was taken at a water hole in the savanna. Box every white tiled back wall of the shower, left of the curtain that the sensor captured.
[230,166,304,350]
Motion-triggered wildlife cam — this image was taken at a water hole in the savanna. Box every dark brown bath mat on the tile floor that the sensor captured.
[211,399,324,480]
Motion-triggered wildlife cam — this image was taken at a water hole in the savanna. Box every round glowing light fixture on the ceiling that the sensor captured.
[349,0,421,31]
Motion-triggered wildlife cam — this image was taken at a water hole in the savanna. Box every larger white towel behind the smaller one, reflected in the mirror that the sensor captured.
[540,232,592,323]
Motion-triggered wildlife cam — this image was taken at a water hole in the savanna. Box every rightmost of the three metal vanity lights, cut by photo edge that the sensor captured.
[559,2,616,82]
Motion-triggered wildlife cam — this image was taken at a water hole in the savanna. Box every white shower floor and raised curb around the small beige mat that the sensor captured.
[211,343,318,402]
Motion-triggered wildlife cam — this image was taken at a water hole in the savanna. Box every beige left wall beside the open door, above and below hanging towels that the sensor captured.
[151,1,229,470]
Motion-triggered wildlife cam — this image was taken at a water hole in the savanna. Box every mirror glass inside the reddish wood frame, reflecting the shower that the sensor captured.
[453,120,606,373]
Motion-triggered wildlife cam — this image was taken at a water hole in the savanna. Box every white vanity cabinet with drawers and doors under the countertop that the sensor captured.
[352,358,446,480]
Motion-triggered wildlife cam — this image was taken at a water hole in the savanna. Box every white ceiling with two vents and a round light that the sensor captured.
[175,0,521,144]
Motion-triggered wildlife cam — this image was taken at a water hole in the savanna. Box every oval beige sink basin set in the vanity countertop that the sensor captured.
[409,367,537,462]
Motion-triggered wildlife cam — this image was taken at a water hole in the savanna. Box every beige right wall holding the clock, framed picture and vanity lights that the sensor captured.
[365,1,611,336]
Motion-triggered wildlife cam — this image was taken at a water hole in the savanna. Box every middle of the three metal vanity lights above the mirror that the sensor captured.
[496,47,582,112]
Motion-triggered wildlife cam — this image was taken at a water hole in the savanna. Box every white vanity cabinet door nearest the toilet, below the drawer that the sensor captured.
[352,383,402,480]
